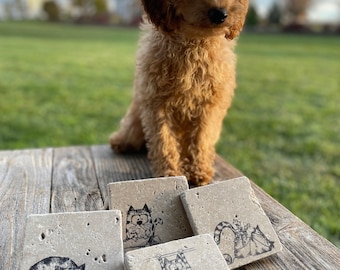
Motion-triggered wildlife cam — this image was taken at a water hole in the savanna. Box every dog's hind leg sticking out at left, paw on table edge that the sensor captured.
[110,100,145,153]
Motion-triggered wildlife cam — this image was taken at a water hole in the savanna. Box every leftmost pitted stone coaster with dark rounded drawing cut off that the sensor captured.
[20,210,124,270]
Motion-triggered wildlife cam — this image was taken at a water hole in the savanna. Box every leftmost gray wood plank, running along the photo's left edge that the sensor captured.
[0,149,53,270]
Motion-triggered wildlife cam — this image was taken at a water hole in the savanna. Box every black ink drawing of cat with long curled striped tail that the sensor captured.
[214,219,274,264]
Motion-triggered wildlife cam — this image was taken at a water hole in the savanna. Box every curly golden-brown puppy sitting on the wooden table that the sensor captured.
[110,0,248,186]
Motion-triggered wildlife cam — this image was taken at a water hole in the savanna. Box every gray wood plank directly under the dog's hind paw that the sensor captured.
[91,145,152,198]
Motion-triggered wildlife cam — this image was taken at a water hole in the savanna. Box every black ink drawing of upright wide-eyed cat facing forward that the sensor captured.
[124,204,163,247]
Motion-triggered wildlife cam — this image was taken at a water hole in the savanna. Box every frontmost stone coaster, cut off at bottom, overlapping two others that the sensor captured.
[125,234,229,270]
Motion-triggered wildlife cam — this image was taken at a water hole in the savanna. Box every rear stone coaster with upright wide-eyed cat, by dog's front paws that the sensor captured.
[108,176,193,251]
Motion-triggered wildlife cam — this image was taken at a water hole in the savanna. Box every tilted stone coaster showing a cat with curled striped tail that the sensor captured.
[181,177,282,269]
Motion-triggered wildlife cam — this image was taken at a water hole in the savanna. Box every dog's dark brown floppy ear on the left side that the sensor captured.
[142,0,179,32]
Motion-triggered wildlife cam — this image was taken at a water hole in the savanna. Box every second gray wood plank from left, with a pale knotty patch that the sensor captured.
[51,147,103,213]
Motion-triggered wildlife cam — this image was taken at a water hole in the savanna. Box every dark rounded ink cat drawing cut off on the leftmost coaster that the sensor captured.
[30,257,85,270]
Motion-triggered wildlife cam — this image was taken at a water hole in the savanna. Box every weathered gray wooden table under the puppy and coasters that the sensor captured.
[0,145,340,270]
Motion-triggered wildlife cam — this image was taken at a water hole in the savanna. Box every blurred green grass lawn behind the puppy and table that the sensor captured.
[0,22,340,247]
